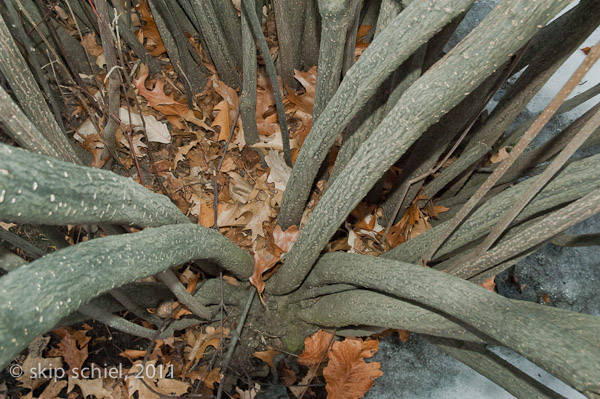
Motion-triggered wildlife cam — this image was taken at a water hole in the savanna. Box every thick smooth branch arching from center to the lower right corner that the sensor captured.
[305,253,600,397]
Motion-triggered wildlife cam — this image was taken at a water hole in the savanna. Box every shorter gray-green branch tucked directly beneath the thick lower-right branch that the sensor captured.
[292,289,494,343]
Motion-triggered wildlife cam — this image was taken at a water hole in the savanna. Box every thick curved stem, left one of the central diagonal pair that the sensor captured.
[277,0,473,229]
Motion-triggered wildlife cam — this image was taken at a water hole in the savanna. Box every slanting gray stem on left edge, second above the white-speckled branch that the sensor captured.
[0,12,81,163]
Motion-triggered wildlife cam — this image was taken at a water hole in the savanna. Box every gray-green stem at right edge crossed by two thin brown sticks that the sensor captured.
[383,155,600,263]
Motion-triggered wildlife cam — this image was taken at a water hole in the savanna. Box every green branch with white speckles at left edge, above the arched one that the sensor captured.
[0,144,189,227]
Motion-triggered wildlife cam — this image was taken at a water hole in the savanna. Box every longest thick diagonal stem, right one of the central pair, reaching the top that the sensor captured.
[267,0,562,294]
